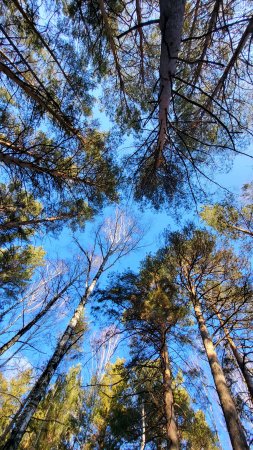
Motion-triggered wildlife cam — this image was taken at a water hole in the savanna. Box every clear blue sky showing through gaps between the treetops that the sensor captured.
[0,95,253,450]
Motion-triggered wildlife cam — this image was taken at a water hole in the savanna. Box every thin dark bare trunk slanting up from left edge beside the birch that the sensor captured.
[0,277,79,355]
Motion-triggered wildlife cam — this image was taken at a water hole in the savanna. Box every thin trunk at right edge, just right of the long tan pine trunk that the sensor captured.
[212,306,253,402]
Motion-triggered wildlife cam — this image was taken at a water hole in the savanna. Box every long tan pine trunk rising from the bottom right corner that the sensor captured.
[192,294,249,450]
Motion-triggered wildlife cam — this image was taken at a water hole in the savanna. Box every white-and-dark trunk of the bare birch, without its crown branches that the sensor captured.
[2,266,103,450]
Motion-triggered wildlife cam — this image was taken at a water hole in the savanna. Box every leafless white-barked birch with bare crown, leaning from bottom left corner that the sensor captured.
[1,212,139,449]
